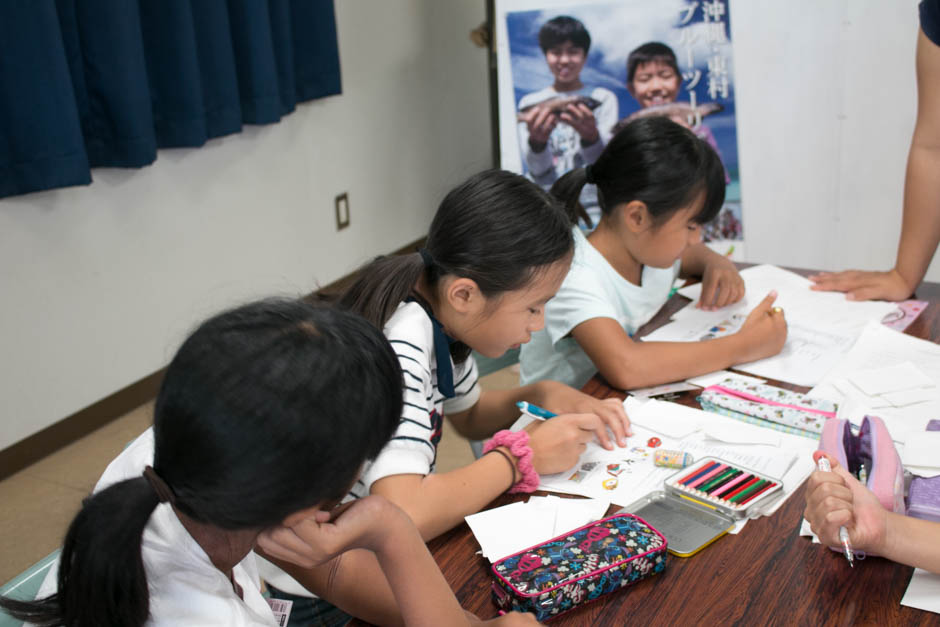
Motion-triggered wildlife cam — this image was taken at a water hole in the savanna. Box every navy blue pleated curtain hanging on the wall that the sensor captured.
[0,0,341,197]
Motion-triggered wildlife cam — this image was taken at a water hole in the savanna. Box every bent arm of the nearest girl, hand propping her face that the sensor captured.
[259,497,534,626]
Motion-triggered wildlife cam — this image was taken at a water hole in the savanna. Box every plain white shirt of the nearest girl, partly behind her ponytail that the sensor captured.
[37,428,277,627]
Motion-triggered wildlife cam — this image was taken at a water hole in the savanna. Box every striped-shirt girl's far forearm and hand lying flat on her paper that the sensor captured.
[448,380,631,448]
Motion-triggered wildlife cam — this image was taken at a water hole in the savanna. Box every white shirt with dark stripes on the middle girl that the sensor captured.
[258,302,480,597]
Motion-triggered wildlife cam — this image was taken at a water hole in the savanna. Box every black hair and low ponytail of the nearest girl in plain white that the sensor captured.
[0,300,402,627]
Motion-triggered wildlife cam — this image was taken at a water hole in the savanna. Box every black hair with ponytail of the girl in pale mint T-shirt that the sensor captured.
[552,116,725,224]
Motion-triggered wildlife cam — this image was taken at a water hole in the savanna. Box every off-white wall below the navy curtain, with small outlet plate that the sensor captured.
[0,0,491,449]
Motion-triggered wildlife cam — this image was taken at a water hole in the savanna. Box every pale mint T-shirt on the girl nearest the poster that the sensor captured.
[520,228,680,388]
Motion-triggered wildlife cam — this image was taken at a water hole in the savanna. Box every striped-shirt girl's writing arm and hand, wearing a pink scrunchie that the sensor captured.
[371,414,612,540]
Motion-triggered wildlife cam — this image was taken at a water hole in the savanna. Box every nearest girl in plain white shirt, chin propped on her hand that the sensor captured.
[0,300,536,627]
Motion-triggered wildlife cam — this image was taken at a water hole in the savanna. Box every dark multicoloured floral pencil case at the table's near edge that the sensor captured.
[493,514,666,622]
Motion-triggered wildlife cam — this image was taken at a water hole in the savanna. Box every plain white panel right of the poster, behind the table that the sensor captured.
[731,0,920,274]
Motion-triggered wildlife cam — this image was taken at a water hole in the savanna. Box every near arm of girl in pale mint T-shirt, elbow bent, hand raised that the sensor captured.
[571,292,787,390]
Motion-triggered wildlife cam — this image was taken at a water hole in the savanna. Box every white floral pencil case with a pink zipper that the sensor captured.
[698,379,838,439]
